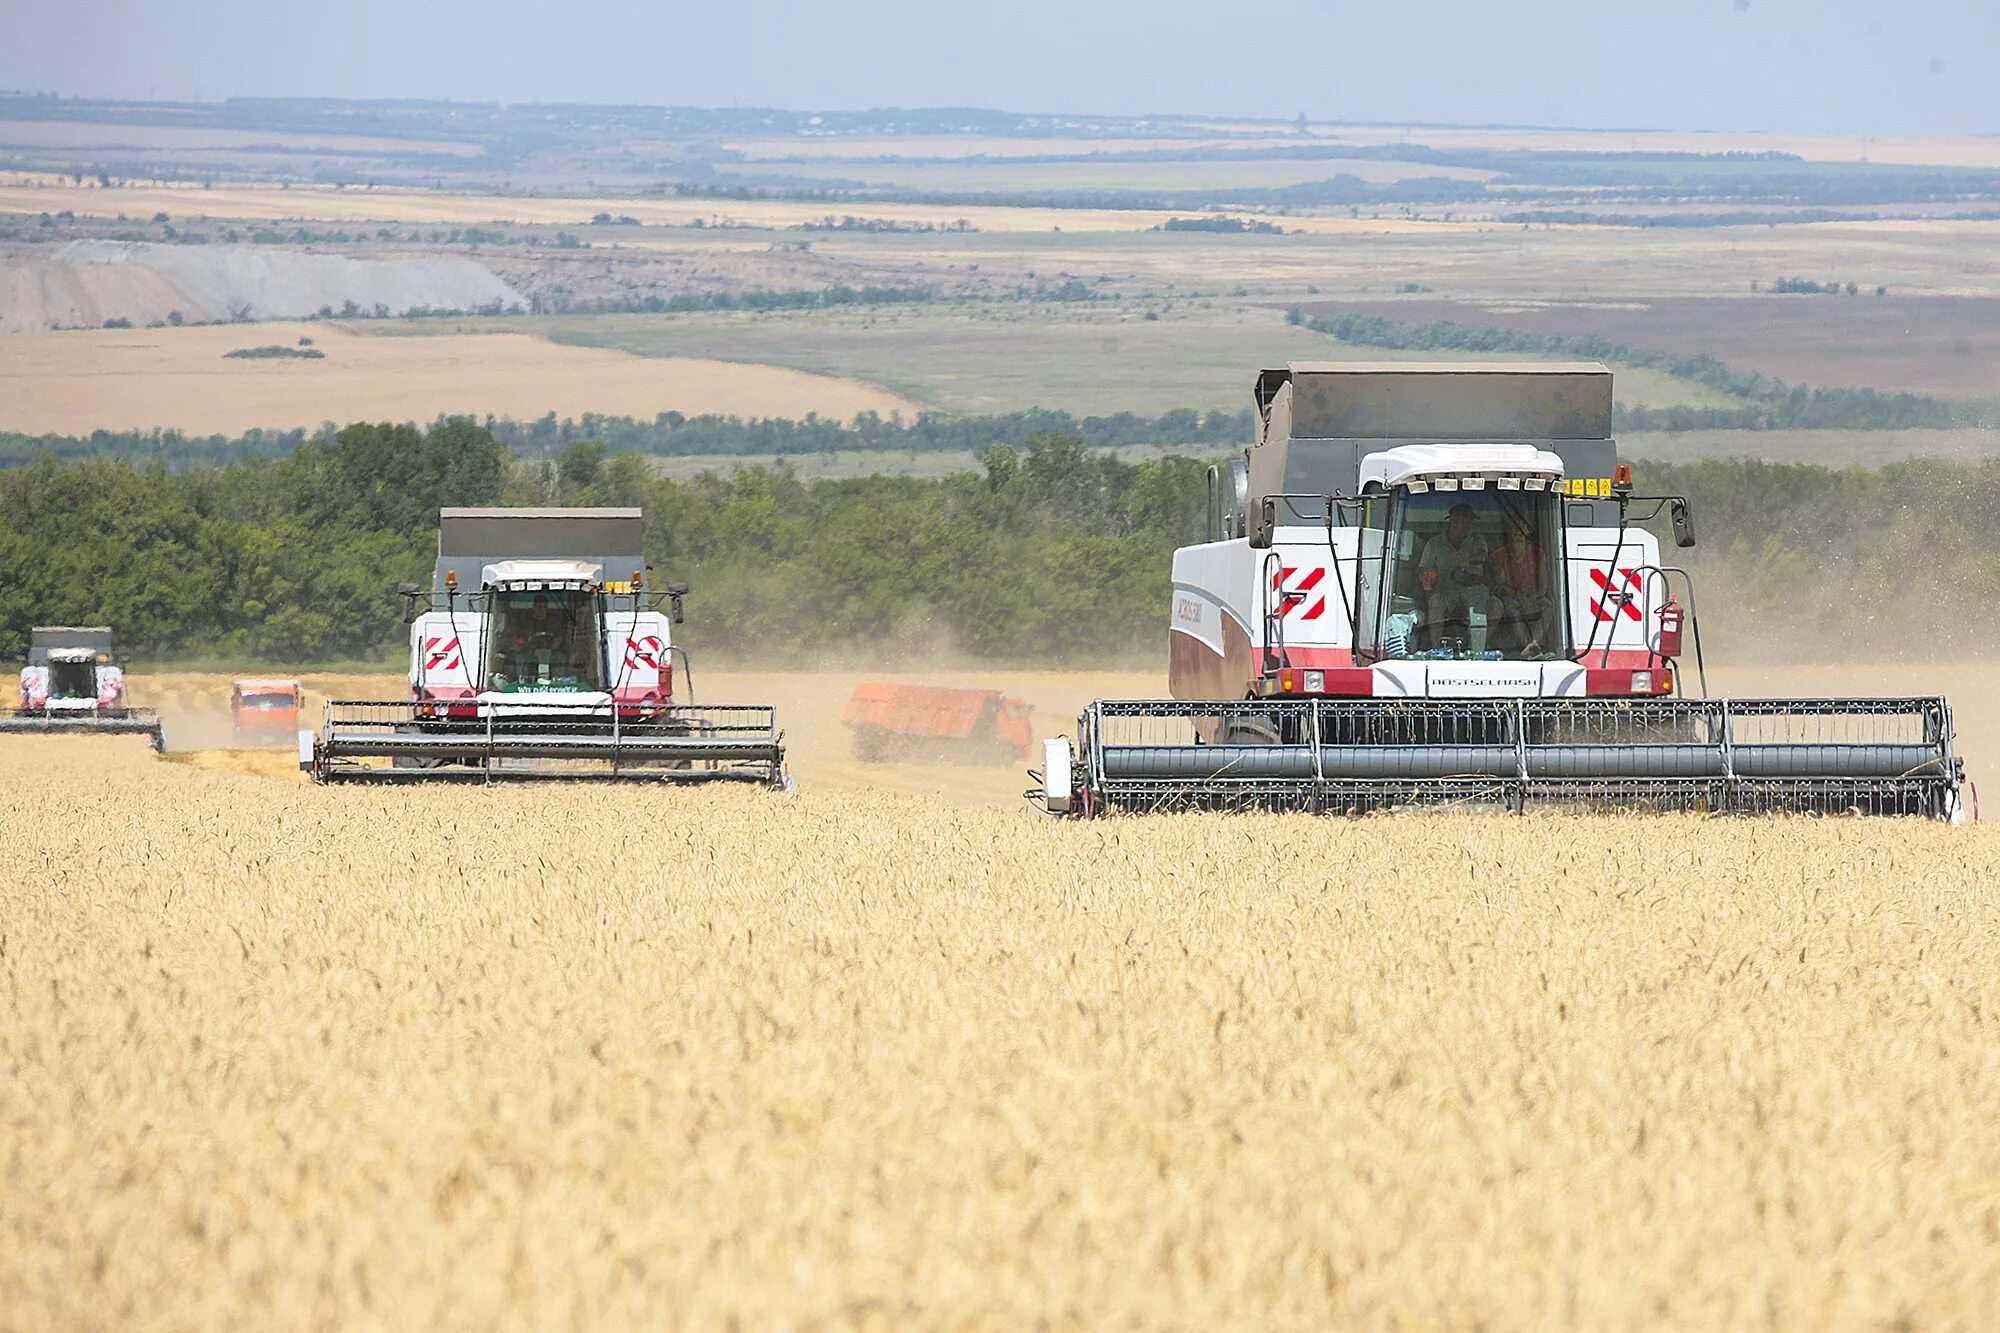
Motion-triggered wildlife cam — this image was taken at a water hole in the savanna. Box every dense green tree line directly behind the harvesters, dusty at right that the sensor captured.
[0,420,2000,667]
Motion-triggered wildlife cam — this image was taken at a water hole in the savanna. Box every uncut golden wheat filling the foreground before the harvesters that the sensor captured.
[0,720,2000,1329]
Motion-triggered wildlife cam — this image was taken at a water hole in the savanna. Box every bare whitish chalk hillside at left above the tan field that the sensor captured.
[0,240,526,332]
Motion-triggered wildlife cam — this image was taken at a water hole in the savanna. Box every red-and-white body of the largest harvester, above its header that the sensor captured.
[1168,362,1692,699]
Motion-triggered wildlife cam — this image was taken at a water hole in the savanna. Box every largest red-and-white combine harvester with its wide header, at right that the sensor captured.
[1032,362,1970,823]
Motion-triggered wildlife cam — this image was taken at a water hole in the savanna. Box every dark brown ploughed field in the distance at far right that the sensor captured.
[1308,298,2000,398]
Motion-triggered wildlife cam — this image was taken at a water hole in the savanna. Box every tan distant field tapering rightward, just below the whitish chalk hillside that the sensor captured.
[0,324,916,434]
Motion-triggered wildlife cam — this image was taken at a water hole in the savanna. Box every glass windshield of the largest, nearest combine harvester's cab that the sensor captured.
[1364,488,1570,662]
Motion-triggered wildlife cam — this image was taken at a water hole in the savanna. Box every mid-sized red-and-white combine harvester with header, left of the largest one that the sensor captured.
[298,508,790,787]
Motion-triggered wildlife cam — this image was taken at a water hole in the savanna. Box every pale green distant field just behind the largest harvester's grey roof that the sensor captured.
[364,302,1726,416]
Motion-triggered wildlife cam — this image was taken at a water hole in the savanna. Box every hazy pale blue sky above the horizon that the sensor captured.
[0,0,2000,134]
